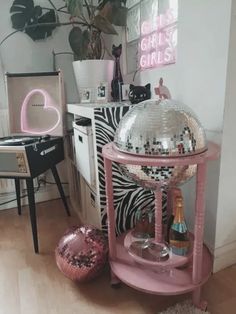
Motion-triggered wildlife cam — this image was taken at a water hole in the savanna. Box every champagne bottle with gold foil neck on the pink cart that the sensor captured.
[169,196,190,256]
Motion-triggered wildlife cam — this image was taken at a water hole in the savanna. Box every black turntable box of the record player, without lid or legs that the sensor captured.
[0,134,64,178]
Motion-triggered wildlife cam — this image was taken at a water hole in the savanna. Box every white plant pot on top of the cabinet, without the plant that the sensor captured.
[73,60,114,102]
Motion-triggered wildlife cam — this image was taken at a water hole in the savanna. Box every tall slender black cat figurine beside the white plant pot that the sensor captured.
[111,44,123,101]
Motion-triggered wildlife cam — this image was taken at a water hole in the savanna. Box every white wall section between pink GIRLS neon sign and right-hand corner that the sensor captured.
[140,0,231,130]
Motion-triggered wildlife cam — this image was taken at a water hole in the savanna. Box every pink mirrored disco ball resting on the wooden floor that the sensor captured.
[55,225,108,282]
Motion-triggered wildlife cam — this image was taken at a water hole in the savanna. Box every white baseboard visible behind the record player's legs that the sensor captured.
[0,184,69,210]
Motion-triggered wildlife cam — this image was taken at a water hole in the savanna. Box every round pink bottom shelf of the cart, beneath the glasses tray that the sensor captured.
[110,234,213,295]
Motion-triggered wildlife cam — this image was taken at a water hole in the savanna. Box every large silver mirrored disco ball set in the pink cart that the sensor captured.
[114,99,207,189]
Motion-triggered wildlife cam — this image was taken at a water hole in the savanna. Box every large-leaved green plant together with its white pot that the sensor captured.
[6,0,127,99]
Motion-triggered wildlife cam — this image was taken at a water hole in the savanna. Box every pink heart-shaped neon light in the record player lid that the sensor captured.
[21,89,61,134]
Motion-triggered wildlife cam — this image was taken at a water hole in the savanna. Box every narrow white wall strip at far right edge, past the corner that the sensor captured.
[215,1,236,270]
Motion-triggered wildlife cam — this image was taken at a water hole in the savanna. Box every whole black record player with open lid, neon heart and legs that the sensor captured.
[0,71,70,253]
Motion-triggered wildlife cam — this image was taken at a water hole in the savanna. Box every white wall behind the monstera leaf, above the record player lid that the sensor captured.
[0,0,71,72]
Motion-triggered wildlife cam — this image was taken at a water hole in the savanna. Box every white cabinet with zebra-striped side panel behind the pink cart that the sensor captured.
[67,102,159,233]
